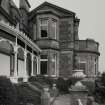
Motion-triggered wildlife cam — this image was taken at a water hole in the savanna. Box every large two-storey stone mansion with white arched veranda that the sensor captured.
[0,0,100,81]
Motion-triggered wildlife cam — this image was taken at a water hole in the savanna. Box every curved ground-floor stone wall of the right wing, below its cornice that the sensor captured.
[75,53,98,77]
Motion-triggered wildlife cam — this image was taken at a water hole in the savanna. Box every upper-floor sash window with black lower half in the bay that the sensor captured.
[40,19,48,38]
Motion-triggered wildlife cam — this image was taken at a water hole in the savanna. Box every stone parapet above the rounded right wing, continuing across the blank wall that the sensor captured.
[60,39,99,54]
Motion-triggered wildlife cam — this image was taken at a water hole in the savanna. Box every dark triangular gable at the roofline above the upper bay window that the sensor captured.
[29,2,75,19]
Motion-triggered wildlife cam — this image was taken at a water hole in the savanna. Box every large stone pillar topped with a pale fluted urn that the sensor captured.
[69,70,88,105]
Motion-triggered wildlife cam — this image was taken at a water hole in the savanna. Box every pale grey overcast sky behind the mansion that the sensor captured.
[14,0,105,72]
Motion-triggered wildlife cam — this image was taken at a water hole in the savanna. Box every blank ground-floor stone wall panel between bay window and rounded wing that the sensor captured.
[59,51,73,78]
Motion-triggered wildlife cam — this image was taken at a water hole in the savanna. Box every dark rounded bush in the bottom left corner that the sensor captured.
[0,76,17,105]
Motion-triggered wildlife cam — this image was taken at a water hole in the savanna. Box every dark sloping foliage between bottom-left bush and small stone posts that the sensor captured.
[15,83,41,105]
